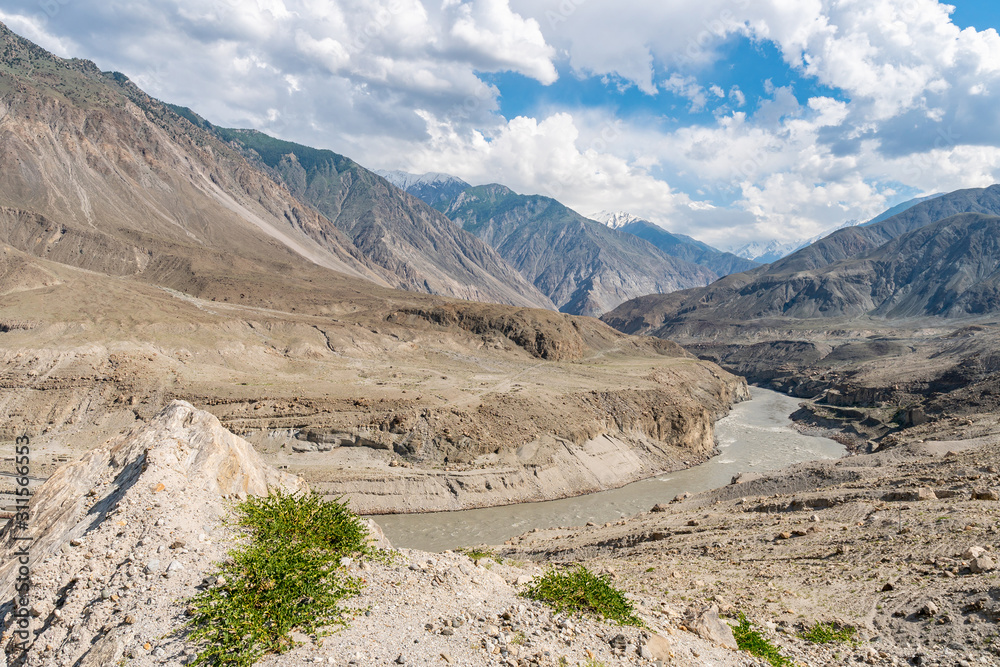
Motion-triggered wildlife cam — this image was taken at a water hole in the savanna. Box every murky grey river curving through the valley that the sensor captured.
[375,387,845,551]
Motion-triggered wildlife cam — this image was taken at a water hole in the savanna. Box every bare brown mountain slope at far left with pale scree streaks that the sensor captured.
[0,25,387,288]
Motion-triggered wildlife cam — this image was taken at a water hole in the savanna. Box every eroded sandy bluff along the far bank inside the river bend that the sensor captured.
[248,366,750,515]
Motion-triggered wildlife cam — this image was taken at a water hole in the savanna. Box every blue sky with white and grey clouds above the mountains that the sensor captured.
[0,0,1000,248]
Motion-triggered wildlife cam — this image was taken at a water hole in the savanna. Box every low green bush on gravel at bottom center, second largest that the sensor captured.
[523,565,643,626]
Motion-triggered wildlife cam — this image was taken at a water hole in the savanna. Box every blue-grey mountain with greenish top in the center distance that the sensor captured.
[446,185,717,316]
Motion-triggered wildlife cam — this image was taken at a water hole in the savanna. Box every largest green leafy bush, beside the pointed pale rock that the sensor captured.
[188,492,375,667]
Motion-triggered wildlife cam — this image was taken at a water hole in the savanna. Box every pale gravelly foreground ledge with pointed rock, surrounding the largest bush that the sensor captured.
[0,402,752,667]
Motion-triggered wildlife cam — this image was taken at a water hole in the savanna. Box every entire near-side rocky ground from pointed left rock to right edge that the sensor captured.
[9,402,1000,667]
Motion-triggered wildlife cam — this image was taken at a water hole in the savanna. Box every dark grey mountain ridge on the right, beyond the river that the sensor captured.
[604,186,1000,336]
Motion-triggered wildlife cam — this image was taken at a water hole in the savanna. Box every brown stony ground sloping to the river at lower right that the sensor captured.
[505,418,1000,665]
